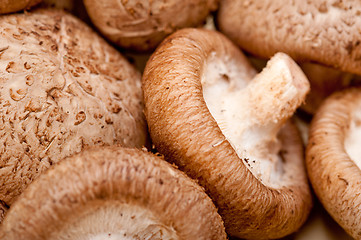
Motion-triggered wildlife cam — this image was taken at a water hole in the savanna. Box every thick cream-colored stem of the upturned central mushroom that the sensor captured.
[219,53,310,160]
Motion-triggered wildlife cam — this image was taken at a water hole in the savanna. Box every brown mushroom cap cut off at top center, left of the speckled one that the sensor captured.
[84,0,218,51]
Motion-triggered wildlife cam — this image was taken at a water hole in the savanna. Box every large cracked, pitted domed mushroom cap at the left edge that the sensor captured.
[0,10,146,218]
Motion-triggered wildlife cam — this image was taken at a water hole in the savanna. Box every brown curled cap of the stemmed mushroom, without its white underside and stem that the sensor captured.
[143,29,312,239]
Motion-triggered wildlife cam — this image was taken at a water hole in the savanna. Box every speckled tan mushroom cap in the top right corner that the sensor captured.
[217,0,361,74]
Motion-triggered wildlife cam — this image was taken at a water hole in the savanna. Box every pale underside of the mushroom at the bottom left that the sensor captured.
[50,201,178,240]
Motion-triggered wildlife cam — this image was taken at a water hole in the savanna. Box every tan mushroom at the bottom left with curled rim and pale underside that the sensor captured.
[0,146,227,240]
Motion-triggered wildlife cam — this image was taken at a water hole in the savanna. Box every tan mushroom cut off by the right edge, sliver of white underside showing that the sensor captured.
[306,88,361,239]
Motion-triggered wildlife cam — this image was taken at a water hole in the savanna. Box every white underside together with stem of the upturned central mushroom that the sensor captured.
[202,54,309,188]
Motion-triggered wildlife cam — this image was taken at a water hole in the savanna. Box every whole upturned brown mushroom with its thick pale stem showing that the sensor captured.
[143,29,312,239]
